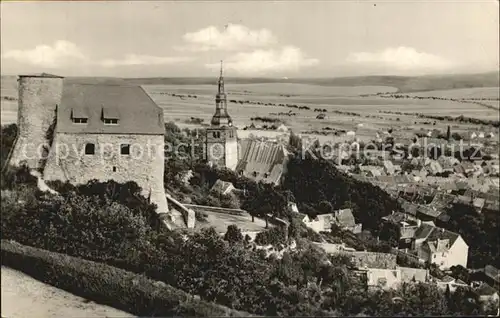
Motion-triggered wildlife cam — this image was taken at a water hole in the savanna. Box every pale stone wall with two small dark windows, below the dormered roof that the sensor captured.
[44,133,168,213]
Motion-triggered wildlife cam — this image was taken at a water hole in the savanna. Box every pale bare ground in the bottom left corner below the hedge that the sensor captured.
[2,266,134,318]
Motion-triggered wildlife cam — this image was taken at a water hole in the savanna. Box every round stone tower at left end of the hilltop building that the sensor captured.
[9,73,63,169]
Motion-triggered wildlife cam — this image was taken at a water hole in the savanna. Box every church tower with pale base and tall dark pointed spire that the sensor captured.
[206,61,238,170]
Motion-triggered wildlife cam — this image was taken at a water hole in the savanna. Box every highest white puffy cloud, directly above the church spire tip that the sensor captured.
[176,24,276,51]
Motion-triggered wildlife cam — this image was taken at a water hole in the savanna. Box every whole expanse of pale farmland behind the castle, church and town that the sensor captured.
[1,75,499,140]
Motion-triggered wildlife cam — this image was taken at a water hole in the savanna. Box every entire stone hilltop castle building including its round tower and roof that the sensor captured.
[9,73,168,213]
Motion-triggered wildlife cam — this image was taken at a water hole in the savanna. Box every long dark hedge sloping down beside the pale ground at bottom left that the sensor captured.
[1,240,248,317]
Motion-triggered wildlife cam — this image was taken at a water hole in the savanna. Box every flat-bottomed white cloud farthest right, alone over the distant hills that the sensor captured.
[347,46,454,72]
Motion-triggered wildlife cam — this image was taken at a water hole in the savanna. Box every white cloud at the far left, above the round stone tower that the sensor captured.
[2,40,86,67]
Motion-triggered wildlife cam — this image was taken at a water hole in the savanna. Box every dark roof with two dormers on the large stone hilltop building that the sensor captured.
[57,82,165,135]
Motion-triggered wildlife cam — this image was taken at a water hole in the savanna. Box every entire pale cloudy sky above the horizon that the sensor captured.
[0,0,499,77]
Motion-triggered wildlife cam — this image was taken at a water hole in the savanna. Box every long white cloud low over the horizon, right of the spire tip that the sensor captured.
[206,46,319,75]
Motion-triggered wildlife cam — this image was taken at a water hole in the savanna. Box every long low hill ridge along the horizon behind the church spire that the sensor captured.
[124,72,500,93]
